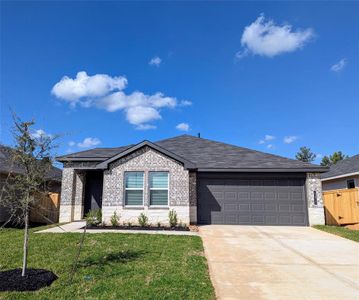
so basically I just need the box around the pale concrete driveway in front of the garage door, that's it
[200,225,359,300]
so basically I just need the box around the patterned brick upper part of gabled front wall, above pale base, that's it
[102,147,189,207]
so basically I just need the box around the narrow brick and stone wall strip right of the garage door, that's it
[306,173,325,225]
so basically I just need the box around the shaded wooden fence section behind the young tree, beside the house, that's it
[30,193,60,224]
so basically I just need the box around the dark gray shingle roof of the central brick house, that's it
[58,135,327,172]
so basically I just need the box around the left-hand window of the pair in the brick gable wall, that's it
[125,172,143,205]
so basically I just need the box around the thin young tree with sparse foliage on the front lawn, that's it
[0,116,56,276]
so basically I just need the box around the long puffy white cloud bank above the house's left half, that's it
[52,72,192,129]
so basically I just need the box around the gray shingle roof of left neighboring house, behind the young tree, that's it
[0,145,62,181]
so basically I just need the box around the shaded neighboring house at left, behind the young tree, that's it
[0,145,62,223]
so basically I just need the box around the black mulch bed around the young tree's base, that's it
[0,269,57,292]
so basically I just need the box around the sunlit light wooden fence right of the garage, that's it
[323,188,359,225]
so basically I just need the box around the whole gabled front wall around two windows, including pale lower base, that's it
[102,147,190,224]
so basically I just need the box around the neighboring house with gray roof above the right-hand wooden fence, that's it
[321,154,359,191]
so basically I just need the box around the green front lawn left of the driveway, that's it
[0,229,215,299]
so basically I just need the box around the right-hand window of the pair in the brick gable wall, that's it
[150,172,168,206]
